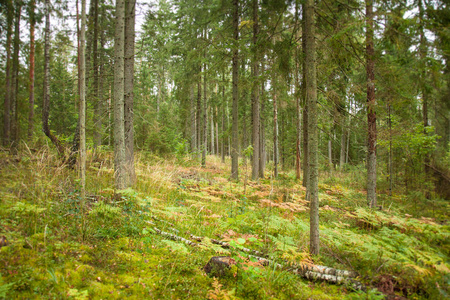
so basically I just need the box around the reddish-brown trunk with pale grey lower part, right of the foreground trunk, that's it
[366,0,377,207]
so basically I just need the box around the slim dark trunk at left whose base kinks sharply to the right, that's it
[42,0,64,156]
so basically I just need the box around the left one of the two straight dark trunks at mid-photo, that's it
[231,0,239,180]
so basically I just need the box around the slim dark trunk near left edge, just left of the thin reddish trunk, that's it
[11,2,22,152]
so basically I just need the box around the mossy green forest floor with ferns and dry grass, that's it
[0,148,450,299]
